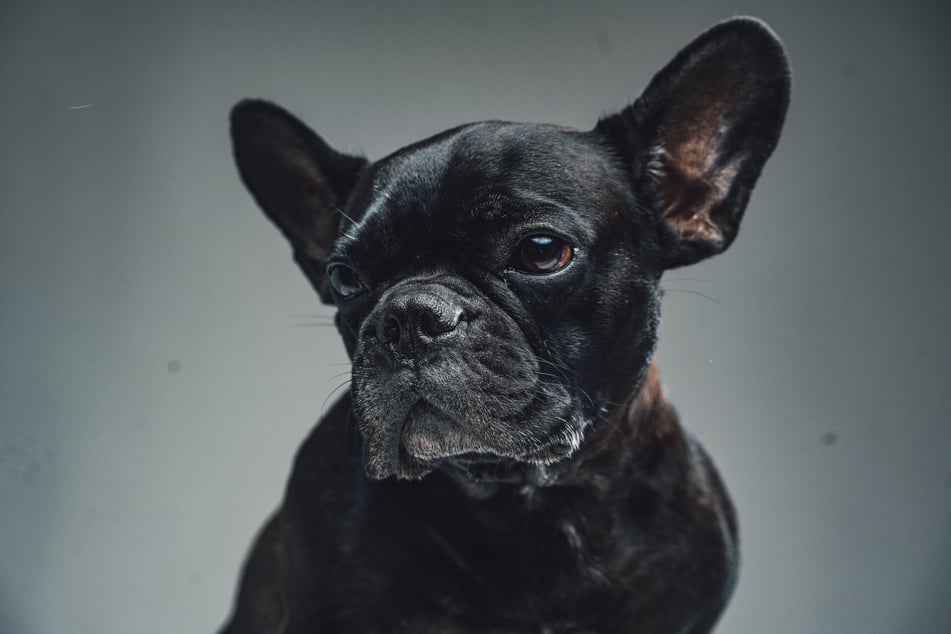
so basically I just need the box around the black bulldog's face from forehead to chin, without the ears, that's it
[327,123,658,477]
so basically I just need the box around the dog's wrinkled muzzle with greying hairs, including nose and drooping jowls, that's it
[353,276,585,481]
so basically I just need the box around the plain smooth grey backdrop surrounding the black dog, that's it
[0,0,951,634]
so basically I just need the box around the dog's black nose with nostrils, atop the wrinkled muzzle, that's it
[376,290,463,353]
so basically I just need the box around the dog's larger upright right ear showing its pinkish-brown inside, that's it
[595,18,790,268]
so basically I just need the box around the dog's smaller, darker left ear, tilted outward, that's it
[231,100,367,304]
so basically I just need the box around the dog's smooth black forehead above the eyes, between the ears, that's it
[340,122,624,251]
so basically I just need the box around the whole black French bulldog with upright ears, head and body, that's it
[223,18,789,634]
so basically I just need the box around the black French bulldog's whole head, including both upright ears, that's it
[232,19,789,480]
